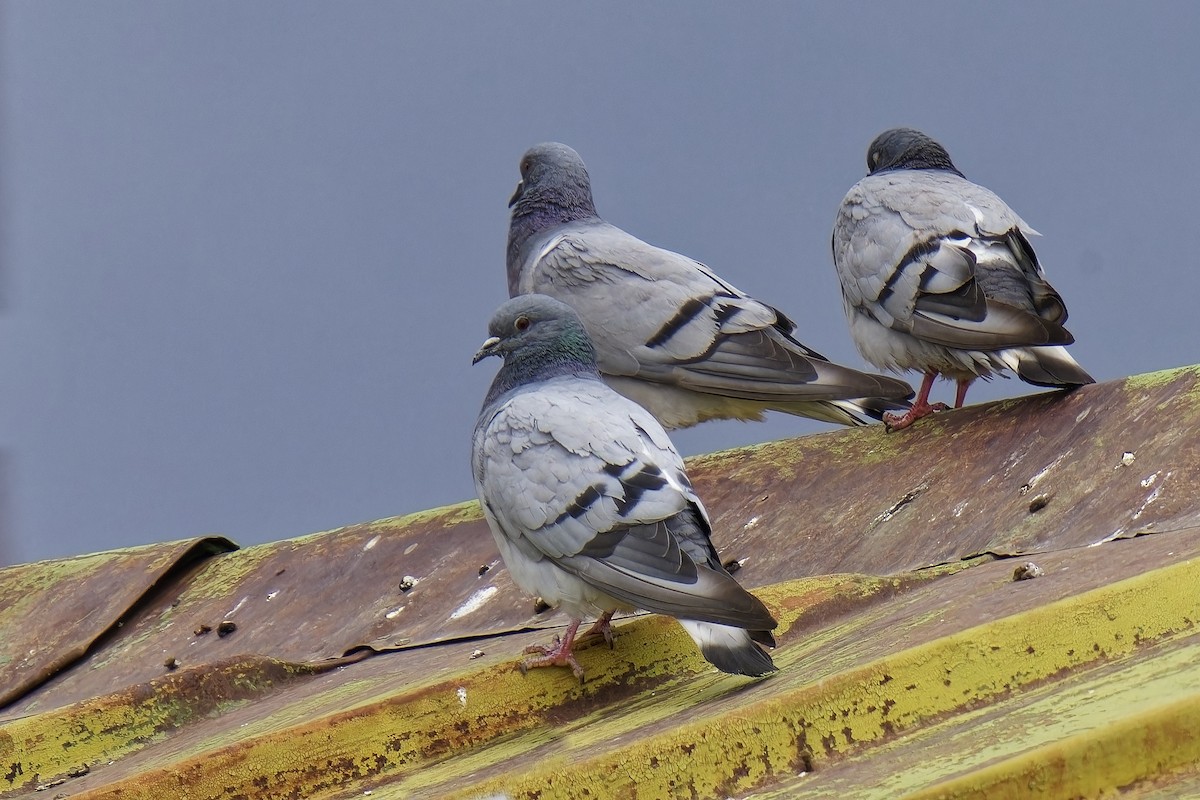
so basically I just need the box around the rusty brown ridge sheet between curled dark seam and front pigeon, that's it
[0,504,542,718]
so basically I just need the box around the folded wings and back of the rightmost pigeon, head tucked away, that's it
[833,170,1072,350]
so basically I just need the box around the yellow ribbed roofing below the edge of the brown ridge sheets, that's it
[0,529,1200,800]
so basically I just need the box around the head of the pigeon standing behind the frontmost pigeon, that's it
[509,142,596,222]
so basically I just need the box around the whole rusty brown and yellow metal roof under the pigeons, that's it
[0,368,1200,800]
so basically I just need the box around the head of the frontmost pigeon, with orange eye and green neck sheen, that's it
[472,294,600,398]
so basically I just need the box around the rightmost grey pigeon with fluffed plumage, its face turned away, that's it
[833,128,1094,429]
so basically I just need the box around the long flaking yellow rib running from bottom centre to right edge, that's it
[450,560,1200,800]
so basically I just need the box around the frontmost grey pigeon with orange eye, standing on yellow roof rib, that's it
[472,295,776,681]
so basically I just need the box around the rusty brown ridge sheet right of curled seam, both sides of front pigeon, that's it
[6,368,1200,715]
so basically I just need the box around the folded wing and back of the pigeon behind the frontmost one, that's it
[518,221,911,403]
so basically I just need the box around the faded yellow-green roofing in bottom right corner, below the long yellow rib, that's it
[751,636,1200,800]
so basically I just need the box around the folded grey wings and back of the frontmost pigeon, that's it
[475,379,775,630]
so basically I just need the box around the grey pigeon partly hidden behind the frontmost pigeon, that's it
[508,143,912,428]
